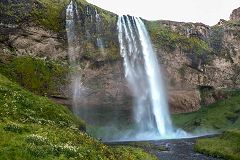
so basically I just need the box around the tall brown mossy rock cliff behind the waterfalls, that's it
[0,0,240,112]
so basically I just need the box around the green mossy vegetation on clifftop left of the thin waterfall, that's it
[0,0,66,31]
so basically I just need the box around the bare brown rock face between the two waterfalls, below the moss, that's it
[79,61,131,107]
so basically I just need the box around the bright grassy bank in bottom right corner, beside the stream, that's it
[195,130,240,160]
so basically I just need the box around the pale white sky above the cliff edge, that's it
[87,0,240,25]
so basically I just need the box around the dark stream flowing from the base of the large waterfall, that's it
[106,138,221,160]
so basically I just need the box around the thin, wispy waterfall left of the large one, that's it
[66,1,83,113]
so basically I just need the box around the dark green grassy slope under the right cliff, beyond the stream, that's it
[173,91,240,132]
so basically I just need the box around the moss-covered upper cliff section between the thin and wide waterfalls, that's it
[71,1,120,62]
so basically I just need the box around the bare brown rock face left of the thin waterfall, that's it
[9,26,67,59]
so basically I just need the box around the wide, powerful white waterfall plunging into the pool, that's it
[118,16,186,140]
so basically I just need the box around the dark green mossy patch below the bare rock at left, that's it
[0,55,68,95]
